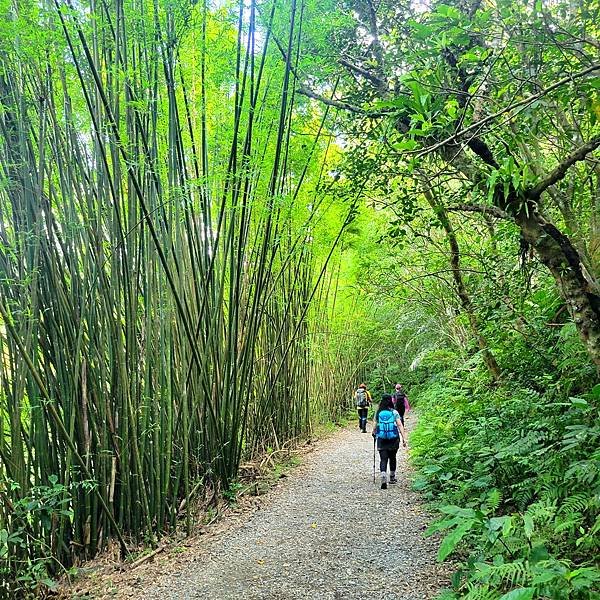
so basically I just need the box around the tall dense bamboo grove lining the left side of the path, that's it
[0,0,356,577]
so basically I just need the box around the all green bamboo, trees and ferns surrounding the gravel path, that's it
[0,0,600,598]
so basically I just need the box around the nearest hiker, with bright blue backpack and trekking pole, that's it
[373,394,407,490]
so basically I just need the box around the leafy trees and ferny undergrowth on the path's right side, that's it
[303,0,600,600]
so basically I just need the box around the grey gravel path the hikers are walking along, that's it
[64,428,448,600]
